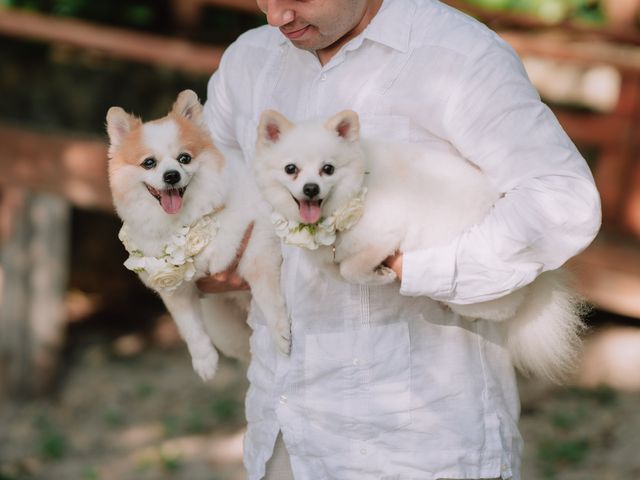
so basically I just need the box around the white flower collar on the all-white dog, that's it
[271,187,367,250]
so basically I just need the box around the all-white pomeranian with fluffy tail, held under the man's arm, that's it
[255,110,583,381]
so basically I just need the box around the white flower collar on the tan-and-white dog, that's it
[118,209,220,292]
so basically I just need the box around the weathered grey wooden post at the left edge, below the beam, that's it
[0,188,70,396]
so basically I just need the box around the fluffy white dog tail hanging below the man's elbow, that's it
[504,270,588,383]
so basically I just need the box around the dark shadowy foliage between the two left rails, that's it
[0,39,208,135]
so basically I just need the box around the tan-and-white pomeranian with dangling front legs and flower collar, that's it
[107,90,290,380]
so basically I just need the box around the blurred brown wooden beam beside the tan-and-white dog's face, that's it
[0,125,113,211]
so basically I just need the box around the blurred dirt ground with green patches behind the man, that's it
[0,317,640,480]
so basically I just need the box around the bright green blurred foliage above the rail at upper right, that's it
[466,0,605,25]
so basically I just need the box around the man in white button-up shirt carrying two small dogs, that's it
[202,0,600,480]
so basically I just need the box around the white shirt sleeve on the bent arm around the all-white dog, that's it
[400,38,600,304]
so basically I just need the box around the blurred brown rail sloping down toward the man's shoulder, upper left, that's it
[0,8,224,74]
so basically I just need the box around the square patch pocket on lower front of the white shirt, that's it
[304,322,411,440]
